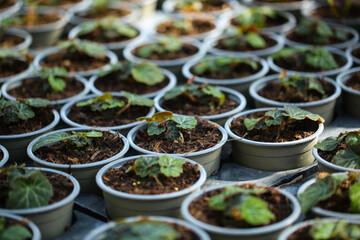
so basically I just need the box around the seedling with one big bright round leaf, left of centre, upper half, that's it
[98,61,165,86]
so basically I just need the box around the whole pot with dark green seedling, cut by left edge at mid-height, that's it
[0,98,60,163]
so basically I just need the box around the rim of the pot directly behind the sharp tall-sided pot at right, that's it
[249,74,341,107]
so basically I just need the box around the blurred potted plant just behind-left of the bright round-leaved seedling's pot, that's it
[34,38,118,76]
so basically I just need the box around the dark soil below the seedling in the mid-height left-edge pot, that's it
[0,108,54,135]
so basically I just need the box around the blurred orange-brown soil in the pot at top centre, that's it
[156,19,215,36]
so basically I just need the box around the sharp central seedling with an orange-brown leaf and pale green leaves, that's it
[137,111,197,143]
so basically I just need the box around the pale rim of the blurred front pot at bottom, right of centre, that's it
[181,183,301,236]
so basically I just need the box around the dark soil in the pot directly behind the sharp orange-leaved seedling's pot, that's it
[161,95,239,116]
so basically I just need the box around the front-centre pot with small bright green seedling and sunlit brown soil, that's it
[96,155,206,219]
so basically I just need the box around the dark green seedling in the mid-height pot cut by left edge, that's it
[0,98,50,124]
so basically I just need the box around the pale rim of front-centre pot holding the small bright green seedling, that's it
[96,154,206,201]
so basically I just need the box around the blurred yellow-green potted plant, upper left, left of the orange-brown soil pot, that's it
[69,17,141,57]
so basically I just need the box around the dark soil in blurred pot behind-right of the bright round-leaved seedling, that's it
[132,43,199,60]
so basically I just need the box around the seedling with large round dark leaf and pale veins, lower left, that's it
[0,165,53,209]
